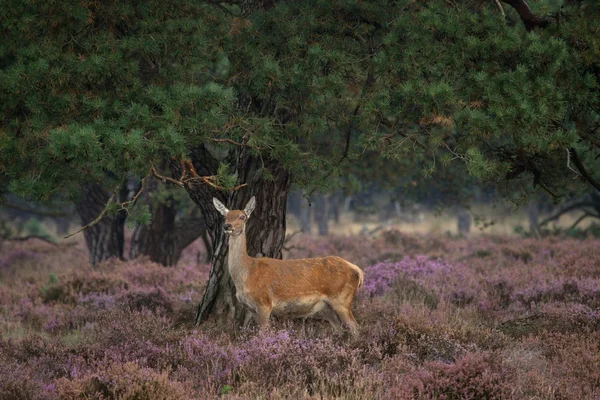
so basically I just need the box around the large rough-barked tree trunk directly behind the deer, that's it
[171,146,290,324]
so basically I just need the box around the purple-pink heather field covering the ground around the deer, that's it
[0,231,600,399]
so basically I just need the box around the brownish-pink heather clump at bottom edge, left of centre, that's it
[56,362,192,400]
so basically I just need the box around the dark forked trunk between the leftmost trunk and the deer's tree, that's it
[129,180,210,267]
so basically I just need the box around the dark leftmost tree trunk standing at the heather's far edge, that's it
[75,184,125,265]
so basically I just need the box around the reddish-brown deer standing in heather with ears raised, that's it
[213,196,364,336]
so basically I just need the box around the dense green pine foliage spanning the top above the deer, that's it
[0,0,600,205]
